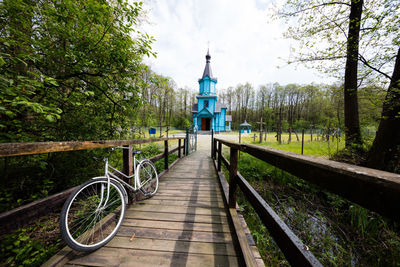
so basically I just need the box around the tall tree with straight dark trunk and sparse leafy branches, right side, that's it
[278,0,399,148]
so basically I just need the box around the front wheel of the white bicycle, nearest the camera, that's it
[60,178,126,252]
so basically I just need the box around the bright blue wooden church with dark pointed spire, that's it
[192,51,232,132]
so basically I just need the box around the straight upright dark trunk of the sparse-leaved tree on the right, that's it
[344,0,364,148]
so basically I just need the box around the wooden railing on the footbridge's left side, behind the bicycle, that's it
[0,137,187,234]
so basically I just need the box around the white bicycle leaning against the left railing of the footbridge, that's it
[60,147,158,252]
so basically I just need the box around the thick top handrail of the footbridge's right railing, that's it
[216,139,400,220]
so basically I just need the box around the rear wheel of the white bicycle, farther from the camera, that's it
[138,160,158,197]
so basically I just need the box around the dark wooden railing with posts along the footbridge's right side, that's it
[211,138,400,266]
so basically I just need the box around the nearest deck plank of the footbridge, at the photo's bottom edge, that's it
[70,247,239,267]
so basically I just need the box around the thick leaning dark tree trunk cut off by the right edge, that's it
[366,47,400,172]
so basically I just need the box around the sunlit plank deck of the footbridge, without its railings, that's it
[49,151,263,266]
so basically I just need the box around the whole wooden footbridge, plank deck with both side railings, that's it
[0,134,400,266]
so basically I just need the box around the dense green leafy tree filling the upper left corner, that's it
[0,0,152,142]
